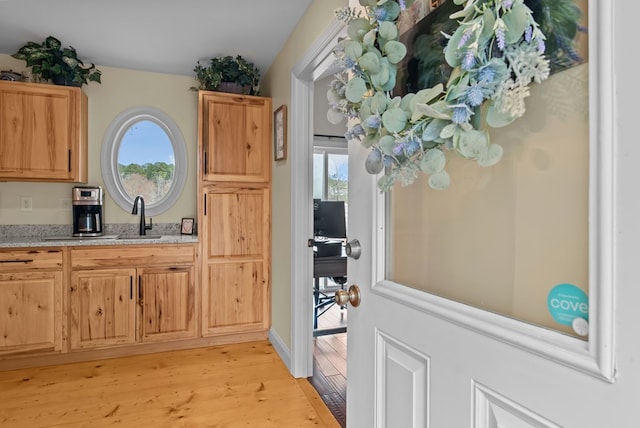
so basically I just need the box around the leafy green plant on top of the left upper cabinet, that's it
[11,36,102,86]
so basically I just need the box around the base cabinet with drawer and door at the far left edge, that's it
[0,249,64,355]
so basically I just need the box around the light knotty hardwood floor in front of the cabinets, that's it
[0,341,339,428]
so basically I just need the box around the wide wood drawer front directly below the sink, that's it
[71,245,196,270]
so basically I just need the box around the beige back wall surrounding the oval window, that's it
[0,54,198,224]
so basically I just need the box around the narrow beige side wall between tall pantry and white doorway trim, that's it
[261,0,347,347]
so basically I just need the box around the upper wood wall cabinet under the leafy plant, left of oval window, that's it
[0,81,88,183]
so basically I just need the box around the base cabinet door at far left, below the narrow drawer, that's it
[0,272,62,355]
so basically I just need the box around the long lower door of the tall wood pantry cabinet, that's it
[202,187,271,335]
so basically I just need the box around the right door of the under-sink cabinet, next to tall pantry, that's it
[138,266,195,342]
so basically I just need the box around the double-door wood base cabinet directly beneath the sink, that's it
[70,245,196,349]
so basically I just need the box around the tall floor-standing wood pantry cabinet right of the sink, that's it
[198,91,272,340]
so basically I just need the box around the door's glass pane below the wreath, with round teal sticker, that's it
[386,0,589,337]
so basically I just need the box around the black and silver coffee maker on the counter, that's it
[71,186,104,236]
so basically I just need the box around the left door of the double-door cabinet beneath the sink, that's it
[70,269,137,349]
